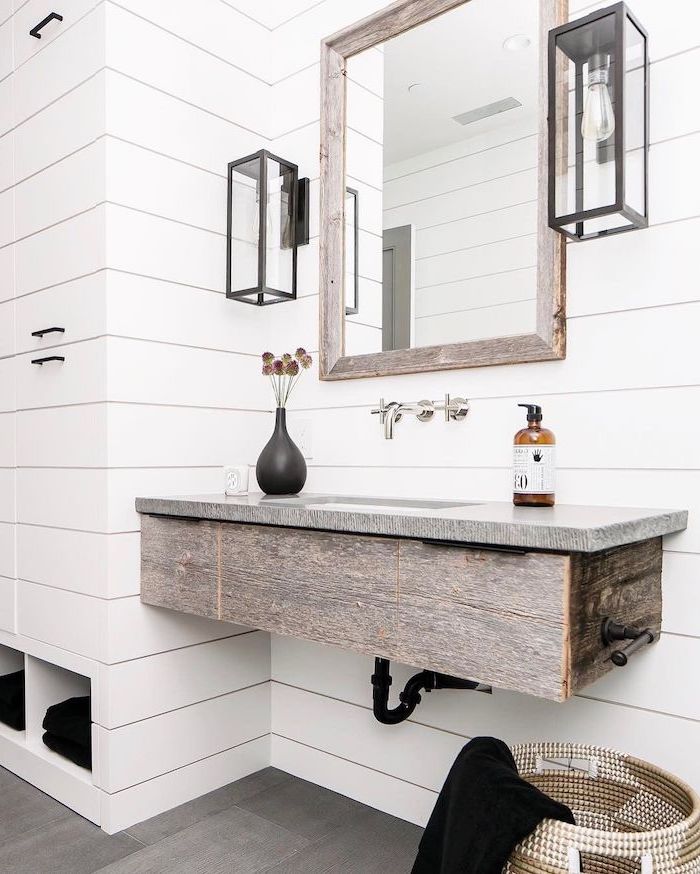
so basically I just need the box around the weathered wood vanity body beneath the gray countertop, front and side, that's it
[142,516,662,701]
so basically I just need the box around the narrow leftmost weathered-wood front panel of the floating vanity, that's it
[141,516,220,619]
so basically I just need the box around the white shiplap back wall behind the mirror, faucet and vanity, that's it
[262,0,700,823]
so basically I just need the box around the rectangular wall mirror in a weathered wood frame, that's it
[319,0,568,380]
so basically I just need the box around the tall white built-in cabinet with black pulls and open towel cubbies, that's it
[0,0,270,832]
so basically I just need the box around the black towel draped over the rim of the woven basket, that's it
[412,737,575,874]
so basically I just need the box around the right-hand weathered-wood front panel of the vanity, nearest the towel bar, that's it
[398,540,569,700]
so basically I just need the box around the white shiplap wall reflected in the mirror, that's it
[384,121,537,346]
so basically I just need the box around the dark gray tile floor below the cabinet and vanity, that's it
[0,768,421,874]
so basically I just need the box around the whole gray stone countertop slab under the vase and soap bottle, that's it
[136,493,688,552]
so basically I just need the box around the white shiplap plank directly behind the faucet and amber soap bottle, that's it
[290,382,700,470]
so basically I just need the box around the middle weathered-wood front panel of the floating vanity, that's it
[220,523,398,657]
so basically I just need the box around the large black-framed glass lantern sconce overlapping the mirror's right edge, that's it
[548,3,649,240]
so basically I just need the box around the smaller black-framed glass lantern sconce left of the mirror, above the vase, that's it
[226,149,309,306]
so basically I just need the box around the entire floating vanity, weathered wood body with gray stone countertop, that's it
[136,495,687,701]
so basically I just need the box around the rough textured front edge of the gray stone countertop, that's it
[136,496,688,552]
